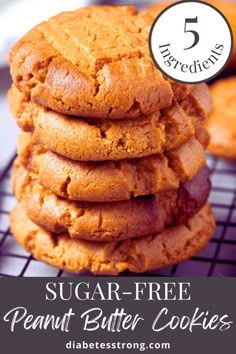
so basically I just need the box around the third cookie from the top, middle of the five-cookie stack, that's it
[18,133,205,202]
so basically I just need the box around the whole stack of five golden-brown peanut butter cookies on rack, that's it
[9,6,214,274]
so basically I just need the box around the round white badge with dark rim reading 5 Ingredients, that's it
[149,1,233,84]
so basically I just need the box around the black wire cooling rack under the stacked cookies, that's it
[0,155,236,277]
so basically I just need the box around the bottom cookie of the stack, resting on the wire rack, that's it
[10,204,215,275]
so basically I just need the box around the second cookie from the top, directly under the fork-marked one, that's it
[8,84,211,161]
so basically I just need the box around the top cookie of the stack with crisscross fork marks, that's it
[9,6,191,119]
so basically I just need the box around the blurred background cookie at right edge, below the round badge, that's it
[207,76,236,159]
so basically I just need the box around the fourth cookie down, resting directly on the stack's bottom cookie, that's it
[12,163,210,241]
